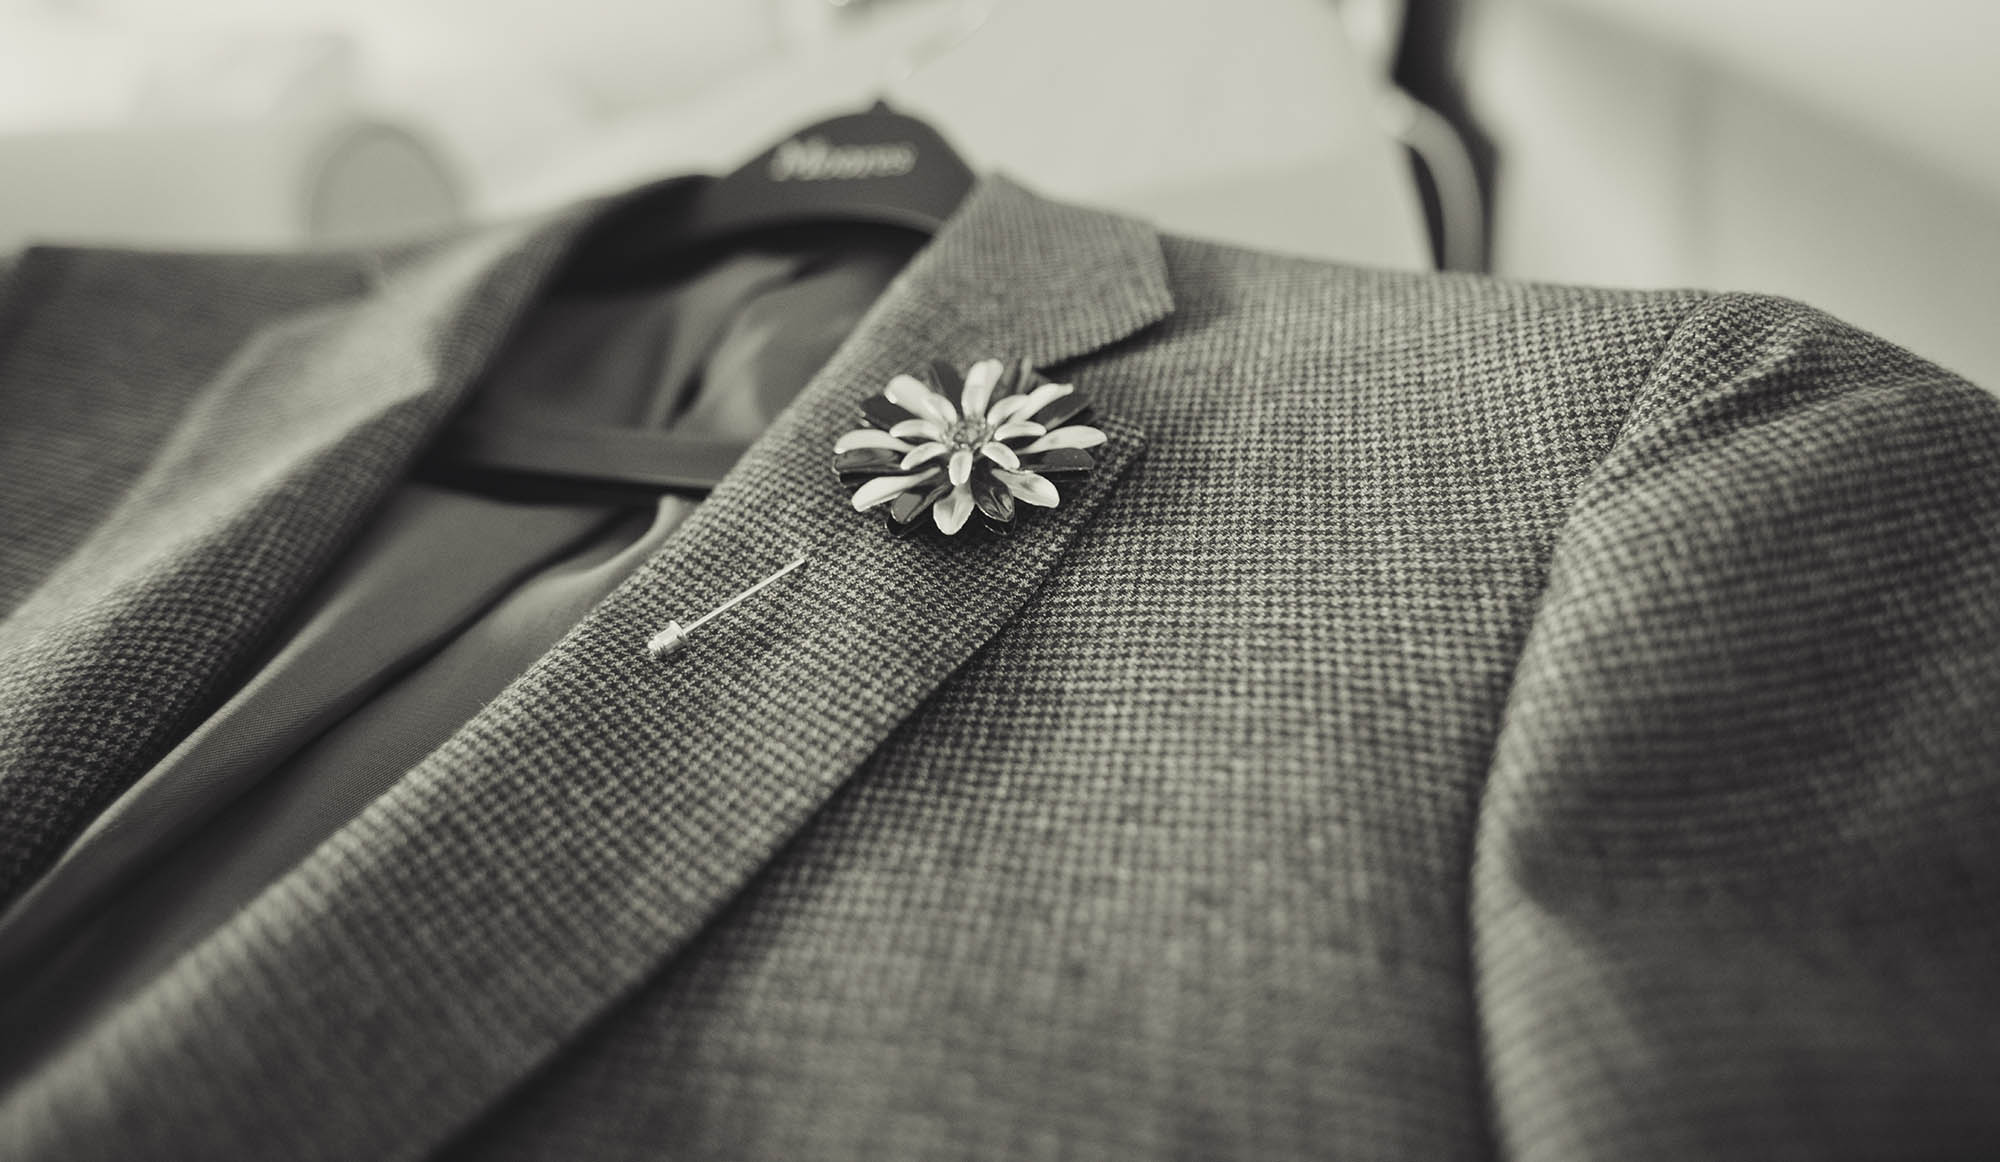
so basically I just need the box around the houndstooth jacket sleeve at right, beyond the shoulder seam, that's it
[1472,296,2000,1160]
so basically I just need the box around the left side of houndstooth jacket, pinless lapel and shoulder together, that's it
[0,226,584,906]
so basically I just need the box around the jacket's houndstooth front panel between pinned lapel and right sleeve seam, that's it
[446,240,1692,1158]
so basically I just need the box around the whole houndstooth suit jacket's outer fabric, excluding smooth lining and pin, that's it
[0,180,2000,1160]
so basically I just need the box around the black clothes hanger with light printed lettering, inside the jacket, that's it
[426,102,976,500]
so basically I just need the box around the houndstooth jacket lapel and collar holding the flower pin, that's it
[0,180,1172,1158]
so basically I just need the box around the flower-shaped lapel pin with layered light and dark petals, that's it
[834,360,1104,536]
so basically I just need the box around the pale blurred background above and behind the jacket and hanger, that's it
[0,0,2000,388]
